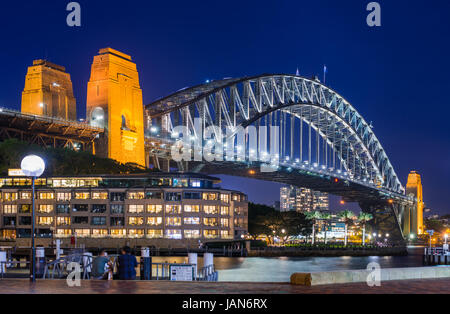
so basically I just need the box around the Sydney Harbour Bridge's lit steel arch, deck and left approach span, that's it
[0,54,418,239]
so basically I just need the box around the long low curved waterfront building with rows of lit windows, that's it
[0,173,248,247]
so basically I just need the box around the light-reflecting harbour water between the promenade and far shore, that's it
[149,247,423,282]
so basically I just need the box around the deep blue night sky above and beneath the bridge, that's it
[0,0,450,213]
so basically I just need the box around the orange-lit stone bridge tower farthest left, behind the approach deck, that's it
[22,60,77,120]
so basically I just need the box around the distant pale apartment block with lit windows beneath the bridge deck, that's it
[280,186,329,212]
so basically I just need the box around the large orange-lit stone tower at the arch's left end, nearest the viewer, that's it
[86,48,145,166]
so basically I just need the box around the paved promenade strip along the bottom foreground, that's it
[0,279,450,294]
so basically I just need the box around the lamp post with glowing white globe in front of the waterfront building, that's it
[20,155,45,282]
